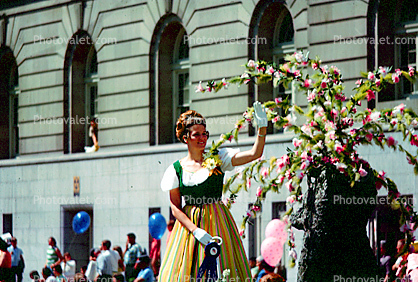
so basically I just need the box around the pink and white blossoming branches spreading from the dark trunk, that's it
[196,52,418,264]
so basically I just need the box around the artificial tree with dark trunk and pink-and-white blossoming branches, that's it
[196,52,418,281]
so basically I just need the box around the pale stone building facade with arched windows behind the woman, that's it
[0,0,418,281]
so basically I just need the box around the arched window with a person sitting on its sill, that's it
[64,30,99,154]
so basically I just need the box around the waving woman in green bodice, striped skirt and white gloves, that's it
[159,102,267,282]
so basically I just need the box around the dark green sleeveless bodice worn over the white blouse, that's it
[173,161,224,206]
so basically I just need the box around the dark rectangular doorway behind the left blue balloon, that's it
[61,205,93,272]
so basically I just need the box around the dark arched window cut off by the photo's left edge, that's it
[0,46,19,159]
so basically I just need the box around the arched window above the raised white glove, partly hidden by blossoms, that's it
[249,0,295,133]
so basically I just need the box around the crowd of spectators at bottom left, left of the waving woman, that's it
[0,233,160,282]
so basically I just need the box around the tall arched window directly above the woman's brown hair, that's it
[150,14,190,145]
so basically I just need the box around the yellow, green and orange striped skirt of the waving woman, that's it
[158,202,251,282]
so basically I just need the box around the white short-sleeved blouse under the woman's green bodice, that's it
[161,148,239,191]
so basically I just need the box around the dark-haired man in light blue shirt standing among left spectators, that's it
[123,233,144,282]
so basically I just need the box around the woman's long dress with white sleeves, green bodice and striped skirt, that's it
[159,149,251,282]
